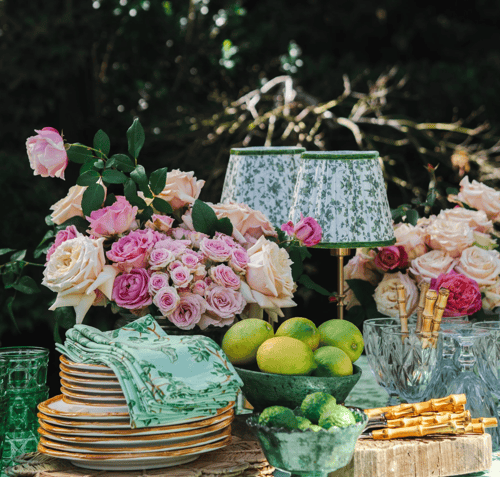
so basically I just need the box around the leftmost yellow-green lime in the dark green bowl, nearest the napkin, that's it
[221,318,274,365]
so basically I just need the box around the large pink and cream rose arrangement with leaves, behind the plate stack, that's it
[2,120,321,330]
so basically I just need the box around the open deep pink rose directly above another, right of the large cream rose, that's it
[106,229,162,272]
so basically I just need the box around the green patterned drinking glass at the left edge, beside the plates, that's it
[0,346,49,467]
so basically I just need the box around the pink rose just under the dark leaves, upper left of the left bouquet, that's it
[87,195,138,237]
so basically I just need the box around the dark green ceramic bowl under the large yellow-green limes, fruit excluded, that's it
[235,365,361,412]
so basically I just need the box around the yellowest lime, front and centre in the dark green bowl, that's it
[257,336,316,375]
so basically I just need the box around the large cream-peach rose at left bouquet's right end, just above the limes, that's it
[240,237,296,319]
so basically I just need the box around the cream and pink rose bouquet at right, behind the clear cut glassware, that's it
[344,177,500,317]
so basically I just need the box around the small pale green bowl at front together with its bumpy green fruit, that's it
[247,392,368,477]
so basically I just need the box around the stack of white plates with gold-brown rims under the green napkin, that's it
[38,357,234,470]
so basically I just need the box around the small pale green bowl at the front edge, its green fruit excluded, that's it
[247,407,368,477]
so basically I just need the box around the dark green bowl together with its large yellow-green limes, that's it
[222,317,363,411]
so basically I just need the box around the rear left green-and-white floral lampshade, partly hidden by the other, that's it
[221,147,305,227]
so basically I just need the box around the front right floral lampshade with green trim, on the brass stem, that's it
[290,151,396,248]
